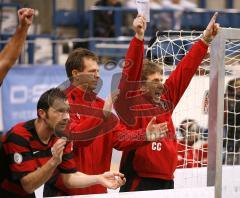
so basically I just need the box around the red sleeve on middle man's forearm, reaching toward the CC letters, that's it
[113,124,148,151]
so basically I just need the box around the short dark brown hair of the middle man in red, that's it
[65,48,98,78]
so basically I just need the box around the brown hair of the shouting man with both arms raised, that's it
[141,59,163,81]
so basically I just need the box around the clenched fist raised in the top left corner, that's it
[18,8,34,28]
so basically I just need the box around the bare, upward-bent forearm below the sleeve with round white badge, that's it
[21,158,57,193]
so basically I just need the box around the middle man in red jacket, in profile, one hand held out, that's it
[44,15,166,197]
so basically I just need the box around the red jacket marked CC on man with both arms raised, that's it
[115,38,208,180]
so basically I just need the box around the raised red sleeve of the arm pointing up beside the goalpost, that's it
[165,40,208,106]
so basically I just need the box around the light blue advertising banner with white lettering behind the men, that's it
[2,65,121,131]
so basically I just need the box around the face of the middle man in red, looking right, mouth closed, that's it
[74,58,100,91]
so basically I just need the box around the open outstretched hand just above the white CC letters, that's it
[146,117,168,141]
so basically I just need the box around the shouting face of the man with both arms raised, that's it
[143,72,163,103]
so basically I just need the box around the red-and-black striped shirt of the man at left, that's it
[0,120,76,197]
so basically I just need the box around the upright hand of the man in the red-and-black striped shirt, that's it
[51,138,67,166]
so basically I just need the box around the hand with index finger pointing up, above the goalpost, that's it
[202,12,220,44]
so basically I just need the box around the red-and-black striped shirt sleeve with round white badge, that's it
[3,132,38,180]
